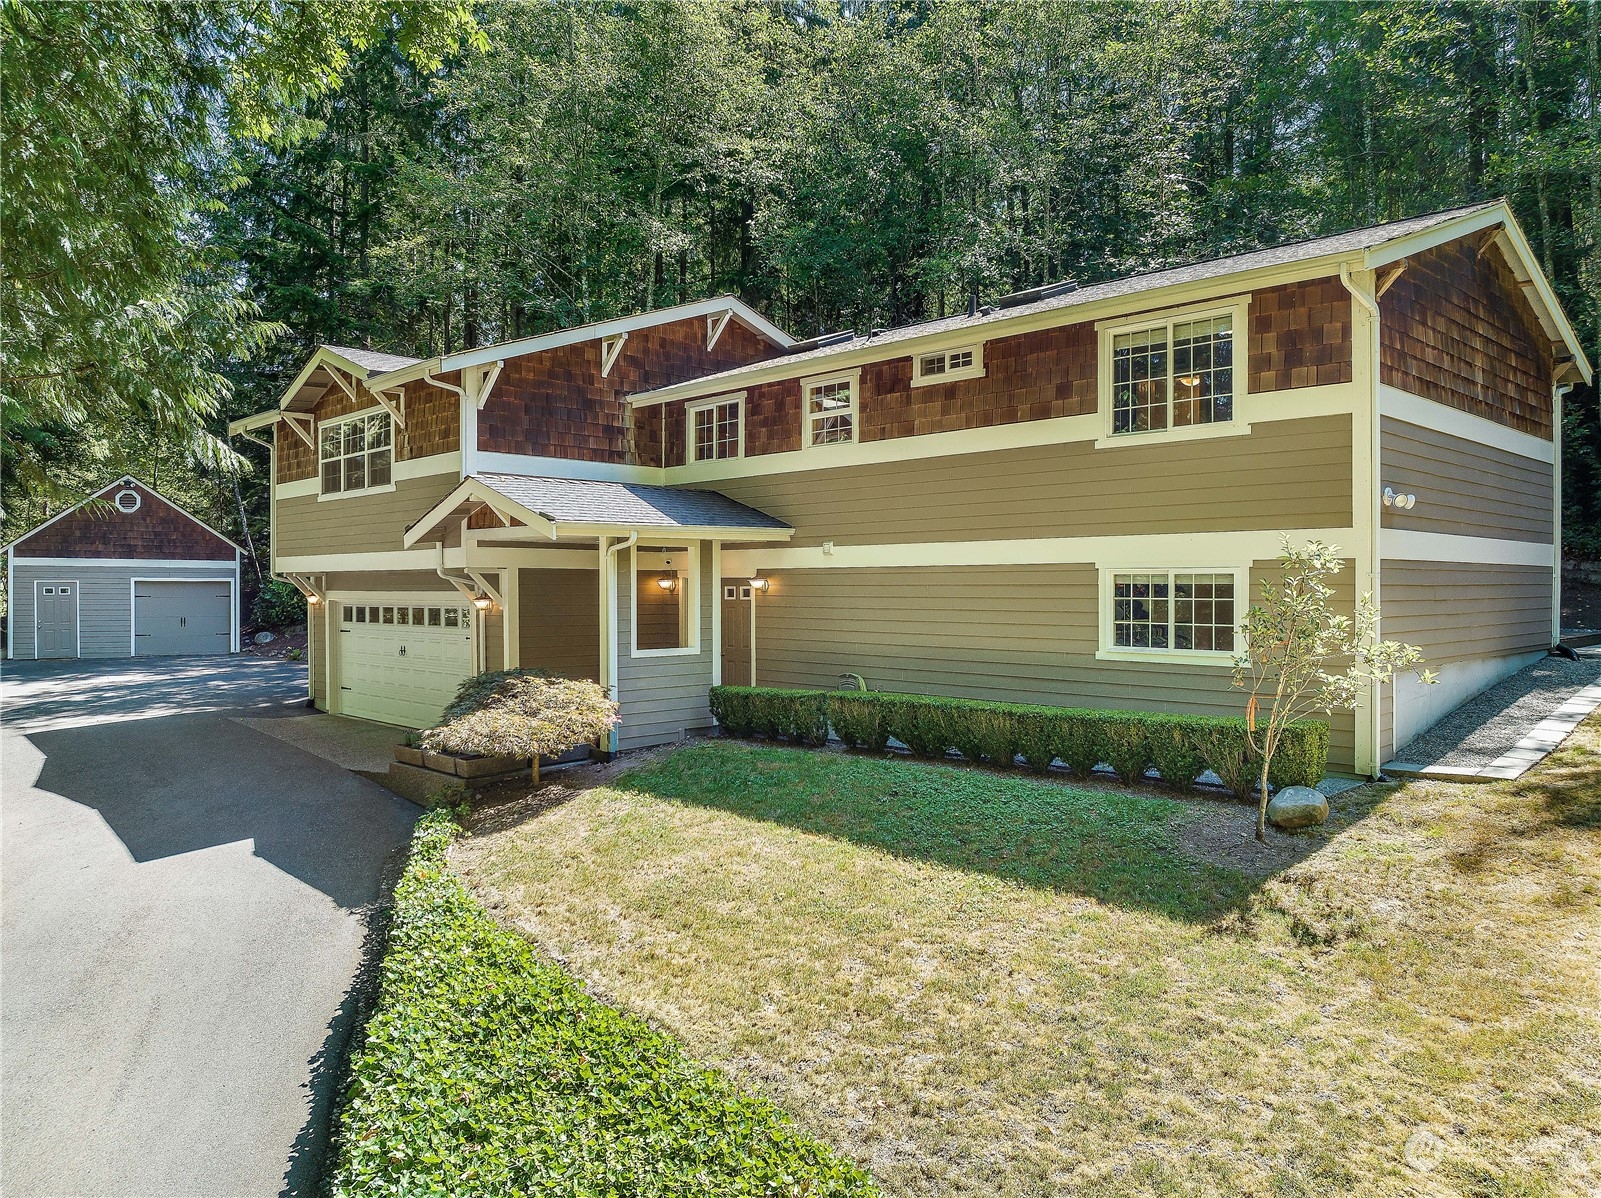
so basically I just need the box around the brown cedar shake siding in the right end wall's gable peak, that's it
[1378,239,1553,440]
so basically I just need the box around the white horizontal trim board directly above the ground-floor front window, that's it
[724,529,1356,577]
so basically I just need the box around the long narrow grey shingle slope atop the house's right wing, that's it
[644,202,1495,394]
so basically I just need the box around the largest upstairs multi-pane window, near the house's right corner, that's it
[1111,312,1234,434]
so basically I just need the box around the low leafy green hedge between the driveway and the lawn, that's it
[330,810,877,1198]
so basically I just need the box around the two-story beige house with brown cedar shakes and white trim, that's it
[234,202,1590,774]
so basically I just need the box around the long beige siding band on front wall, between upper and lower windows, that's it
[716,415,1351,546]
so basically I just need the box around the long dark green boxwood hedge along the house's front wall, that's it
[711,687,1329,796]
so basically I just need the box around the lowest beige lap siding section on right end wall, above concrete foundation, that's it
[1380,560,1551,666]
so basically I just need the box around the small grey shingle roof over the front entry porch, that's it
[472,474,789,532]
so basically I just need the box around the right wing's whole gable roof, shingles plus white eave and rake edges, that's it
[629,200,1590,407]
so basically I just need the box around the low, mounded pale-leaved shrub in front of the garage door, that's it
[419,669,616,758]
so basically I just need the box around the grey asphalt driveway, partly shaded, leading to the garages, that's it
[0,657,418,1198]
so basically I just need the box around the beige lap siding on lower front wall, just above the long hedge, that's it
[756,562,1354,770]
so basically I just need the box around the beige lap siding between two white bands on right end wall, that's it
[1378,416,1553,543]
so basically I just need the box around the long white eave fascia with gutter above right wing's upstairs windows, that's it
[628,248,1362,408]
